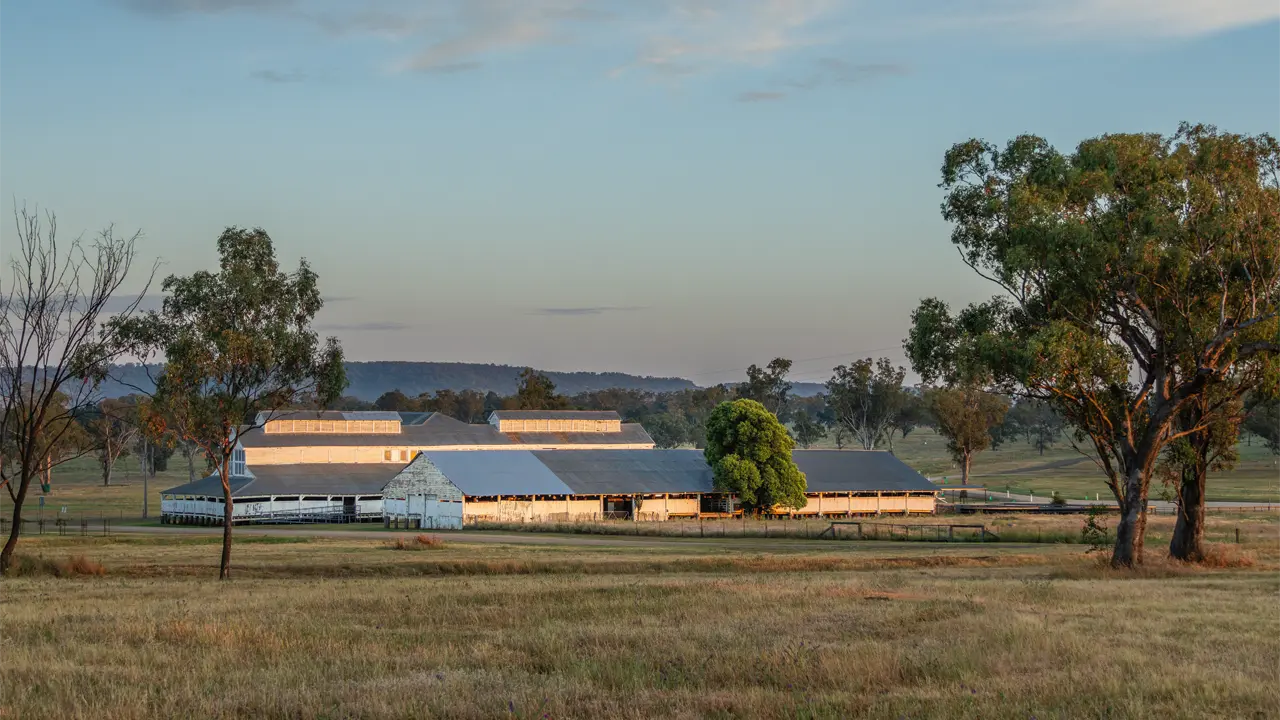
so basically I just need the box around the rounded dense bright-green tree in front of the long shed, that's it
[704,400,808,512]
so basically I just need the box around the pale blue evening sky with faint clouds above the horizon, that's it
[0,0,1280,384]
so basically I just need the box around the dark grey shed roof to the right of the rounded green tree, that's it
[791,450,937,492]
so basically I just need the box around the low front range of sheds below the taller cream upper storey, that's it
[161,448,937,528]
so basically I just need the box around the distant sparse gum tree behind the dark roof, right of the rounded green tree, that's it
[827,357,908,450]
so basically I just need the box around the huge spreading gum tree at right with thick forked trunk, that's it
[909,126,1280,566]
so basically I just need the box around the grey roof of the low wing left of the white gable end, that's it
[163,462,404,497]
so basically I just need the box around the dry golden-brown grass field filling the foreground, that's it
[0,519,1280,720]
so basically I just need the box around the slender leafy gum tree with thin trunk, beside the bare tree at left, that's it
[115,228,347,579]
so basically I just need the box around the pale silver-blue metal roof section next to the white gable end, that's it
[424,450,573,497]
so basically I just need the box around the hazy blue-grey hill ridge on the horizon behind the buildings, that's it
[99,361,696,401]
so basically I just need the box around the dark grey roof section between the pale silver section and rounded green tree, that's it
[534,450,714,495]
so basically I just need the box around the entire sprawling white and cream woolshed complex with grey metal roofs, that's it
[161,411,937,520]
